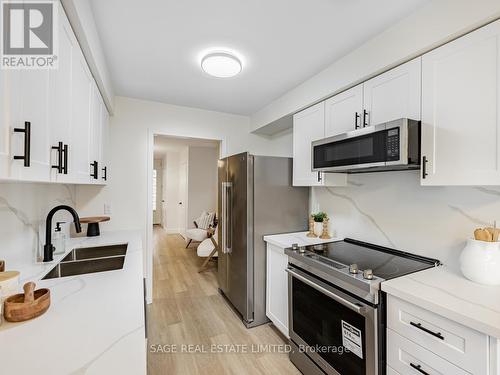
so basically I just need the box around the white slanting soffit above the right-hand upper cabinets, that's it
[251,0,500,132]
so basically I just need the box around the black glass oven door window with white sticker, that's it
[292,278,366,375]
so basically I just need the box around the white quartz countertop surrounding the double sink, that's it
[0,231,146,375]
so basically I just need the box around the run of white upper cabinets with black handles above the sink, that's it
[0,2,108,184]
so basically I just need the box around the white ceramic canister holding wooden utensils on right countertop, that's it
[460,239,500,285]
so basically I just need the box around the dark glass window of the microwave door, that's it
[314,130,387,168]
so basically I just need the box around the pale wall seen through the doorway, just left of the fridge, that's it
[187,147,219,228]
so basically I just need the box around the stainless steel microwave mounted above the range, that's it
[312,118,421,173]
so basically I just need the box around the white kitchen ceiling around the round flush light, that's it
[90,0,429,115]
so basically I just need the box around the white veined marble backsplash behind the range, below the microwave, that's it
[310,171,500,269]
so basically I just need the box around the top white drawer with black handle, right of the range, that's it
[387,296,489,374]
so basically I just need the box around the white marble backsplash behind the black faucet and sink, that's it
[0,182,76,269]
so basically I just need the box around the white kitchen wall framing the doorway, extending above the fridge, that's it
[77,97,292,301]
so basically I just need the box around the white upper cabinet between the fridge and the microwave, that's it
[293,102,346,186]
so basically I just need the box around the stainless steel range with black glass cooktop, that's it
[285,239,440,375]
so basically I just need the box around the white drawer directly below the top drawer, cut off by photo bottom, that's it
[387,328,470,375]
